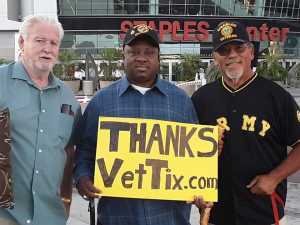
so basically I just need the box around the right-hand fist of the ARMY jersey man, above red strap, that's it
[247,174,278,195]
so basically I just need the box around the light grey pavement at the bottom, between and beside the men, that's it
[68,182,300,225]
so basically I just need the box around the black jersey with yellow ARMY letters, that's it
[192,75,300,225]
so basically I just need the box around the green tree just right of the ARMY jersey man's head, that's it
[256,42,288,82]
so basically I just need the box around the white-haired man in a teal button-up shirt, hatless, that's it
[0,16,81,225]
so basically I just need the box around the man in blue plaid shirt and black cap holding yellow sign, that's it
[75,25,197,225]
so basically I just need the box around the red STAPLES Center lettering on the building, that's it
[120,20,289,42]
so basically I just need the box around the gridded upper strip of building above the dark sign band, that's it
[58,0,300,18]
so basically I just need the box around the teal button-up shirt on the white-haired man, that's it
[0,62,81,225]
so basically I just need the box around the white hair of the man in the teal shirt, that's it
[19,15,64,41]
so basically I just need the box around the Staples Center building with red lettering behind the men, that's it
[57,0,300,80]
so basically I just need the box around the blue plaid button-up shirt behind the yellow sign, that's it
[75,78,197,225]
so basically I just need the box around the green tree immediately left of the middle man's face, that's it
[99,48,122,80]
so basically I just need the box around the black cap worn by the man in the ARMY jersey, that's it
[213,21,250,51]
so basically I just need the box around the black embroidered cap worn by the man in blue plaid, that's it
[123,24,159,48]
